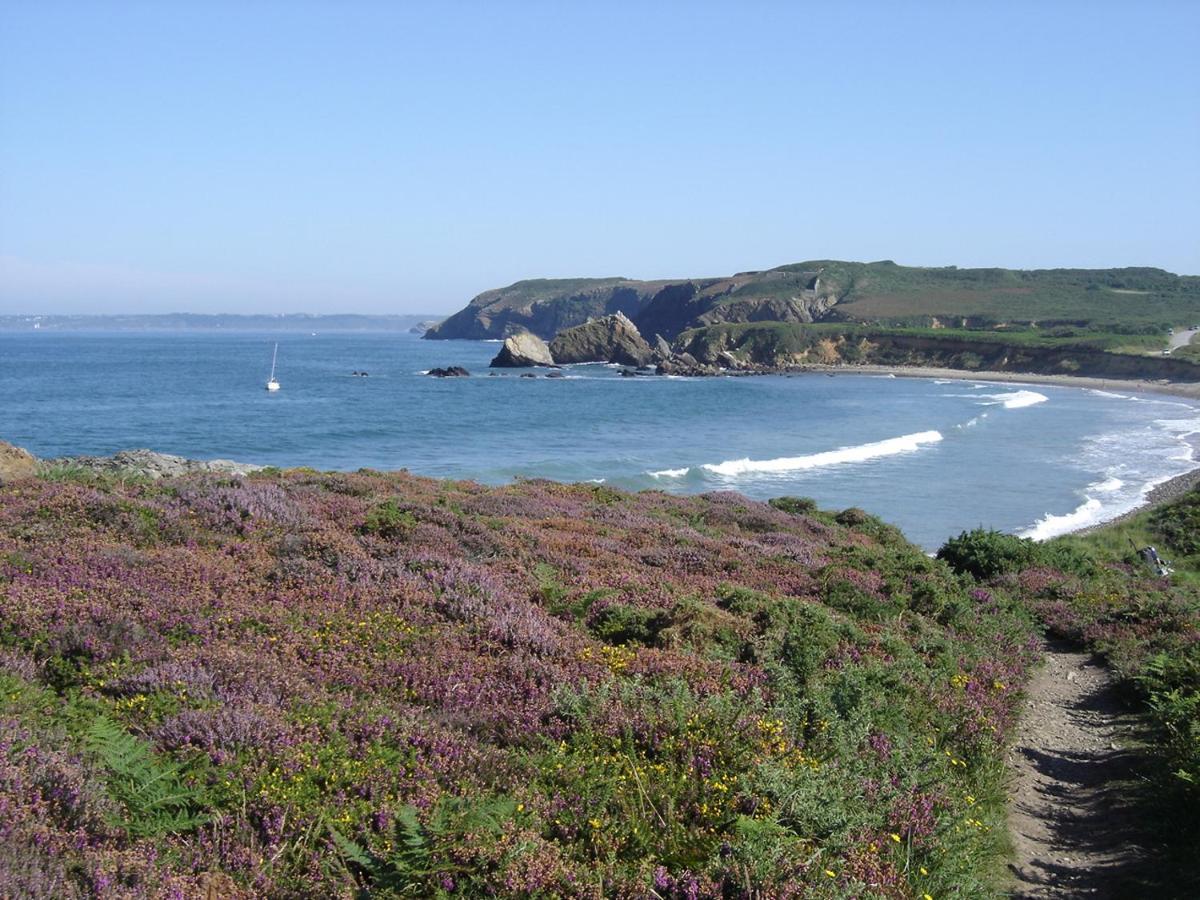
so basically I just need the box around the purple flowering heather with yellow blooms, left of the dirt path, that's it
[0,470,1036,900]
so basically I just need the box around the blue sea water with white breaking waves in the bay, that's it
[0,331,1200,548]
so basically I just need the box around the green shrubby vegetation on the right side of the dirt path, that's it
[938,488,1200,896]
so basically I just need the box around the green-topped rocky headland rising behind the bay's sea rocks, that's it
[426,259,1200,340]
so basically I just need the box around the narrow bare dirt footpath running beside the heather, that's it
[1008,646,1148,899]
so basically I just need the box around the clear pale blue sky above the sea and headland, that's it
[0,0,1200,313]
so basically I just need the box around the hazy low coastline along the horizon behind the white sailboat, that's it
[0,313,440,331]
